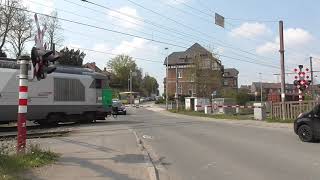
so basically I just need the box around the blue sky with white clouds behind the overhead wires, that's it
[20,0,320,94]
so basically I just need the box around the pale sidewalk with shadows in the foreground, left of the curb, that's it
[25,125,149,180]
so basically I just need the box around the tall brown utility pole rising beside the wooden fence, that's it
[279,21,286,119]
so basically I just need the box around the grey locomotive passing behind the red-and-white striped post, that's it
[0,60,112,124]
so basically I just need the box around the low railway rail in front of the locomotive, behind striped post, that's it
[0,130,71,139]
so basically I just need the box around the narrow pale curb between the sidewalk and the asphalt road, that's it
[130,129,159,180]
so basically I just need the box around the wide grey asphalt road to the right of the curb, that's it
[124,105,320,180]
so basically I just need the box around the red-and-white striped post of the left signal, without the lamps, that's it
[17,56,30,153]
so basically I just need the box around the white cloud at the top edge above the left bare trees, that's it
[23,0,55,14]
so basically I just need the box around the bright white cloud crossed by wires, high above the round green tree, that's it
[108,6,142,28]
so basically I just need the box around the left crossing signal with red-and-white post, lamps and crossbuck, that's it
[17,14,59,153]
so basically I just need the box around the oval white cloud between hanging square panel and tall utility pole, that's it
[230,22,271,38]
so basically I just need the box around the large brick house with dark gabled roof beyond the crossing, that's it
[164,43,223,97]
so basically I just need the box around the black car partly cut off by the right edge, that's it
[294,104,320,142]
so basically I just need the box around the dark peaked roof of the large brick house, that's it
[163,43,212,65]
